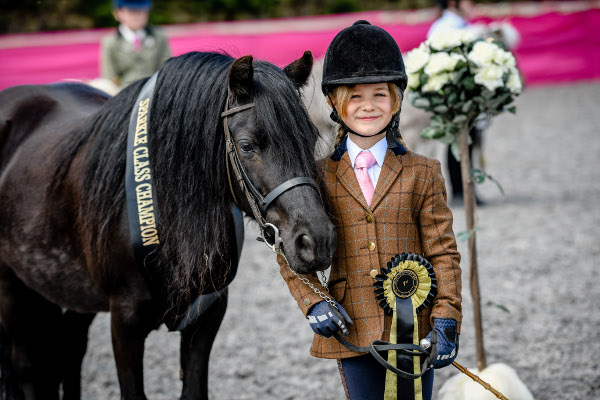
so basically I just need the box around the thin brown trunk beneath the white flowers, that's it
[458,124,487,371]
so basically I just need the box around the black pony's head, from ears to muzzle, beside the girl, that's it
[227,52,335,273]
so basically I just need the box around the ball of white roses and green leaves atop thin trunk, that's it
[405,29,522,151]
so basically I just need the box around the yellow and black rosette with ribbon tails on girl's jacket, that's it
[373,253,437,400]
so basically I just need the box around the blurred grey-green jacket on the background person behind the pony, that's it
[100,26,171,88]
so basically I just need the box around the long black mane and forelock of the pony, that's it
[52,53,318,304]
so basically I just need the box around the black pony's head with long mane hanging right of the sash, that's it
[145,53,336,295]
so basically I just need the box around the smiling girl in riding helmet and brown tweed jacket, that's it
[278,21,462,400]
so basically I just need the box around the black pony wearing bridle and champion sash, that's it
[0,52,335,399]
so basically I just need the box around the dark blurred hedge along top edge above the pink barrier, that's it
[0,0,510,33]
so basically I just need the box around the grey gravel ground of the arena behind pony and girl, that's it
[82,83,600,400]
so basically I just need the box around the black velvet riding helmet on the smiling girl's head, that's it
[321,20,407,96]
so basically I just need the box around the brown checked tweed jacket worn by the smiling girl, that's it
[278,141,462,359]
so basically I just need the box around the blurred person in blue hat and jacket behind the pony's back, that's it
[100,0,171,89]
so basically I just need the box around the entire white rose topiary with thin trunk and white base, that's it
[406,30,533,400]
